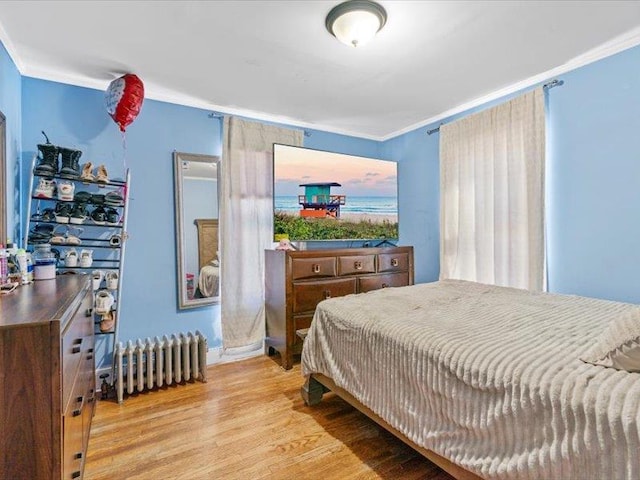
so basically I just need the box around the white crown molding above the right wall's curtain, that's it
[380,27,640,142]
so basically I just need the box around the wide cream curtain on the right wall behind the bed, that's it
[440,88,546,291]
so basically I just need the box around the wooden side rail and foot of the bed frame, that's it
[300,373,482,480]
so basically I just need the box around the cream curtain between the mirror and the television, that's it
[220,117,303,348]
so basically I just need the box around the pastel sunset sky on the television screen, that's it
[274,145,398,197]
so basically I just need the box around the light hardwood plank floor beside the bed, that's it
[84,356,453,480]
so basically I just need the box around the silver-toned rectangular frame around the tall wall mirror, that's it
[173,151,220,310]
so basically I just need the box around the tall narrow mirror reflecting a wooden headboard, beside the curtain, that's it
[173,152,220,309]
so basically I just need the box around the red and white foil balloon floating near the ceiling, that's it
[105,73,144,132]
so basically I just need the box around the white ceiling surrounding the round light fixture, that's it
[0,0,640,139]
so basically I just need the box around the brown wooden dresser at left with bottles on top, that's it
[0,275,95,480]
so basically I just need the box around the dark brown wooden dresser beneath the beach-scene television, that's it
[265,247,413,370]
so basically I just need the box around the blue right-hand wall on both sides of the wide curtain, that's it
[381,42,640,303]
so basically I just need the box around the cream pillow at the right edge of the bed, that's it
[580,308,640,372]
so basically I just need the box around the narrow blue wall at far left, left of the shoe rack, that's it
[0,43,22,243]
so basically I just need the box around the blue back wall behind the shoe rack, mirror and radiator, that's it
[21,77,379,366]
